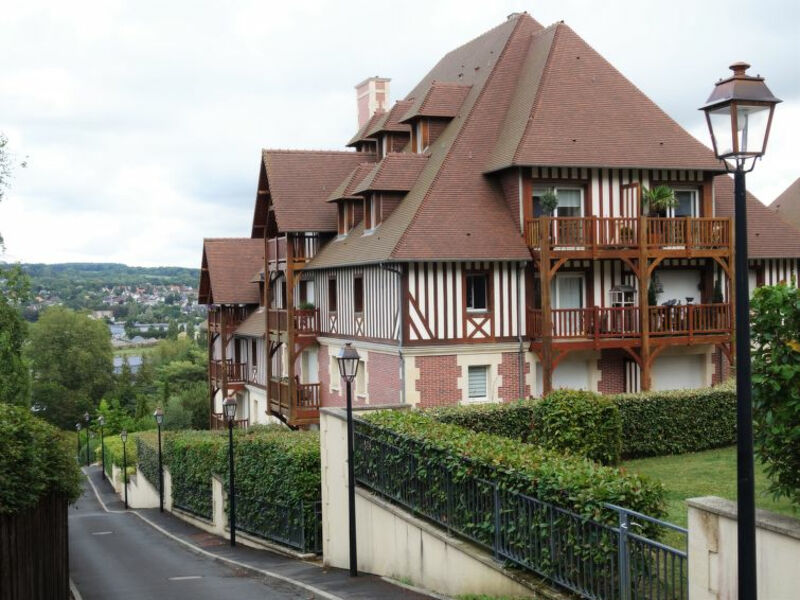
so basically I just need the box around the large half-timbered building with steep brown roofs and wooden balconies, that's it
[200,13,800,426]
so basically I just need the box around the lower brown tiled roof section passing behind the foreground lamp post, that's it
[714,175,800,258]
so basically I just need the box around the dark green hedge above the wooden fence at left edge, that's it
[0,404,80,514]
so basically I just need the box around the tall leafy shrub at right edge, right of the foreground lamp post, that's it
[751,282,800,505]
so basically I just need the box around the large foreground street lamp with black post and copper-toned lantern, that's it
[700,62,780,600]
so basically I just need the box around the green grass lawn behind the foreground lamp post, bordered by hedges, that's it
[622,446,800,545]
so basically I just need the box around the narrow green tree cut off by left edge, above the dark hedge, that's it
[0,264,30,406]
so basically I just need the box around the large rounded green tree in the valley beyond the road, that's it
[26,306,113,429]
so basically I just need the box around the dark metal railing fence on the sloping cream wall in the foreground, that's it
[354,421,688,600]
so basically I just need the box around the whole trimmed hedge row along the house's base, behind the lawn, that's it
[426,382,736,465]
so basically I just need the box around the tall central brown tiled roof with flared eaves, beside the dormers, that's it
[307,14,541,268]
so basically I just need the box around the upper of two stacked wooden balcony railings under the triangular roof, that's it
[525,217,731,258]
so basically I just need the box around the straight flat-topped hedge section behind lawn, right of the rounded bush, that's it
[613,382,736,458]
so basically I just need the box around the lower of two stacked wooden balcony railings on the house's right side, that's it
[528,304,732,340]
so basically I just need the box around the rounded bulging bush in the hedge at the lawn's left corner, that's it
[529,390,622,465]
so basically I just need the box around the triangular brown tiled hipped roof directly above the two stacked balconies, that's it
[486,23,724,171]
